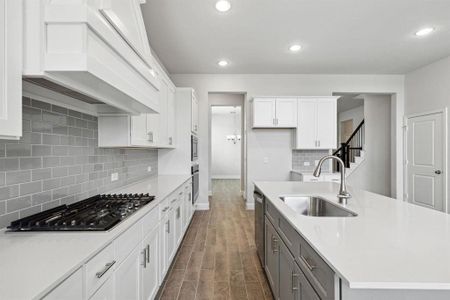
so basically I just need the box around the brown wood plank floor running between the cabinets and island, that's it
[160,180,273,300]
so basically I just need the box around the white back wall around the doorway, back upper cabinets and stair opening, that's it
[172,74,404,208]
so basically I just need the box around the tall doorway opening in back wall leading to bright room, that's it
[209,93,245,196]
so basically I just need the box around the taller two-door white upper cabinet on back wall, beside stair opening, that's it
[296,97,337,149]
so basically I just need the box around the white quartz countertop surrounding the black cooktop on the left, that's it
[0,175,190,300]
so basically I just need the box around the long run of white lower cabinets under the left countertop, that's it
[42,180,193,300]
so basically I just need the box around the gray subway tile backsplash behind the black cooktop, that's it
[0,97,158,228]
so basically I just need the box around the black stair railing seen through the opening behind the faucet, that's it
[333,120,365,171]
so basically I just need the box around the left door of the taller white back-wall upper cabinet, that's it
[296,99,317,149]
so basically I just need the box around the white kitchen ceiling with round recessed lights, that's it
[142,0,450,74]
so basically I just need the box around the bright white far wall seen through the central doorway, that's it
[211,107,241,179]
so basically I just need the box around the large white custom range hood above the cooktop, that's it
[23,0,160,114]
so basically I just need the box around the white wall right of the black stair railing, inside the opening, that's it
[348,95,391,196]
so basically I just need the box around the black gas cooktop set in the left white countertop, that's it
[8,194,155,231]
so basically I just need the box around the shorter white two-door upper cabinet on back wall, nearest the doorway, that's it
[253,98,297,128]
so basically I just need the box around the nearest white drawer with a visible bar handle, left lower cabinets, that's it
[85,244,116,298]
